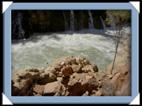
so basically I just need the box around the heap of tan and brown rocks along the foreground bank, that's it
[12,56,130,96]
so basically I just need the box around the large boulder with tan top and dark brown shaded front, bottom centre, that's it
[68,73,98,96]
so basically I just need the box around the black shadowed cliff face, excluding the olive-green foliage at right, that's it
[12,10,105,39]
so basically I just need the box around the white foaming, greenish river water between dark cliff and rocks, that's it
[12,33,115,70]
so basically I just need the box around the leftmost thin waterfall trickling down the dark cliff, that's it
[17,13,25,39]
